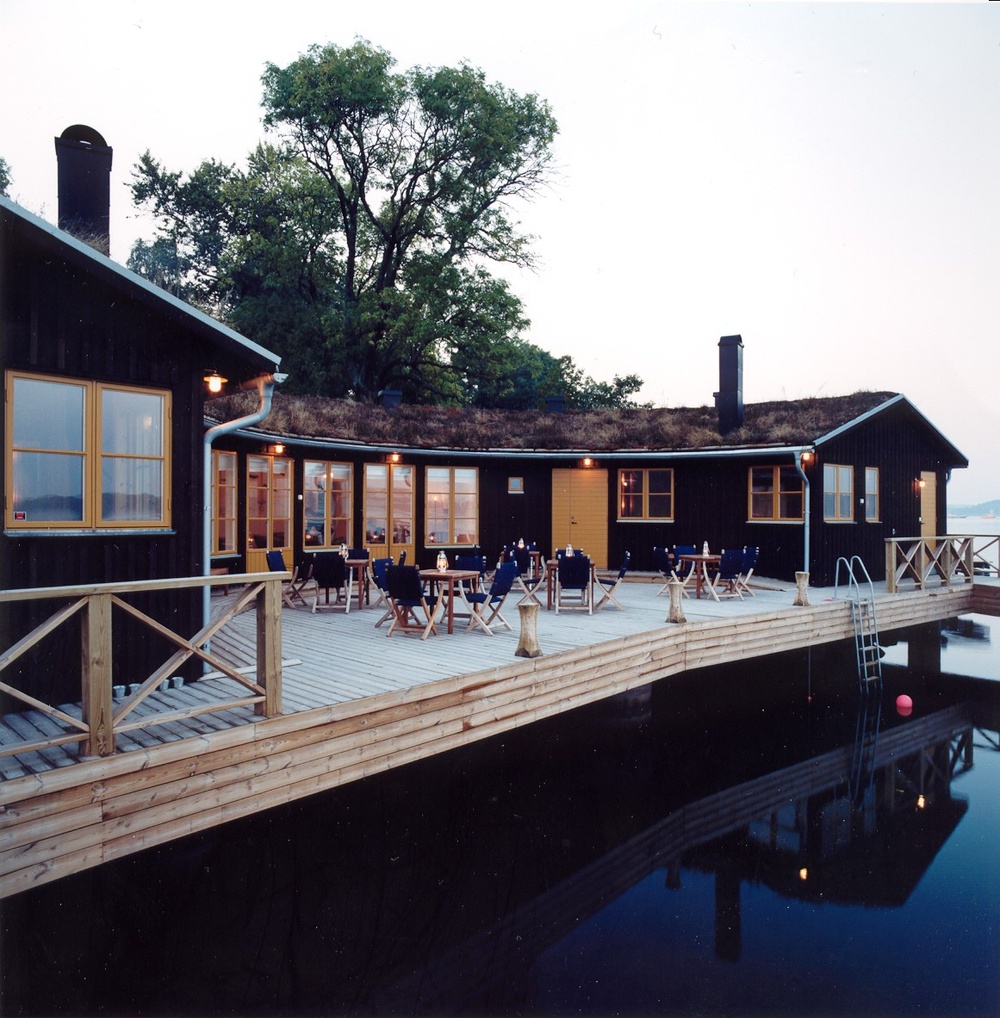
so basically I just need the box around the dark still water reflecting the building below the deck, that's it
[0,617,1000,1015]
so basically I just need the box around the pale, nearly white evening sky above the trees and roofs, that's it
[0,0,1000,504]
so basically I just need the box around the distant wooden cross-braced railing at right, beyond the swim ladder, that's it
[885,533,1000,593]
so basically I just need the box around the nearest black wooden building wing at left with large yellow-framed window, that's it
[0,181,279,699]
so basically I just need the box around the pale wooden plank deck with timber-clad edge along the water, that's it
[0,579,1000,894]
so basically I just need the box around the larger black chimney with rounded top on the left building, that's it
[56,124,111,255]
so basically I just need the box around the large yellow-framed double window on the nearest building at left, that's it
[4,372,171,529]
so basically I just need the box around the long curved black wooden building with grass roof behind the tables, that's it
[209,337,967,585]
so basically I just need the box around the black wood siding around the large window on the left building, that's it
[0,215,246,701]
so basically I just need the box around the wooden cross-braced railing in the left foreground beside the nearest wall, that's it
[0,572,290,756]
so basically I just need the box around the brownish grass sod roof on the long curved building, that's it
[205,391,896,452]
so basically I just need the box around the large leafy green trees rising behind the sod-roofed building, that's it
[129,40,642,406]
